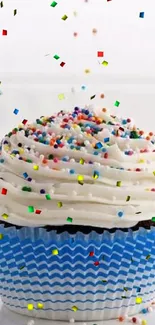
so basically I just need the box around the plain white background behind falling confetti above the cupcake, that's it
[0,0,155,136]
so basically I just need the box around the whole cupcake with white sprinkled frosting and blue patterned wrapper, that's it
[0,107,155,321]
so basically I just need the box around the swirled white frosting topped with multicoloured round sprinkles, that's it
[0,107,155,228]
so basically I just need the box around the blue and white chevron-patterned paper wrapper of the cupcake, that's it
[0,225,155,321]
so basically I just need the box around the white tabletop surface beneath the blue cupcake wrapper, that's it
[0,300,155,325]
